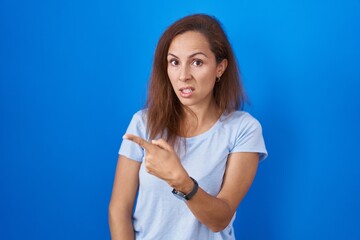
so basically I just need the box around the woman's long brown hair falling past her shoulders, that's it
[146,14,245,144]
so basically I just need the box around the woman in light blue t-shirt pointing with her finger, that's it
[109,14,267,240]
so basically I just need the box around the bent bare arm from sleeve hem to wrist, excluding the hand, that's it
[179,153,259,232]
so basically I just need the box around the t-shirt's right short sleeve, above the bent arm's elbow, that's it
[230,114,268,161]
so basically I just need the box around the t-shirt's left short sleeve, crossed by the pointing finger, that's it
[119,110,148,162]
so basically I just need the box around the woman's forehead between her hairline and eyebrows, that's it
[169,31,211,54]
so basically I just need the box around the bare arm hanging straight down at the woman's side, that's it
[109,156,140,240]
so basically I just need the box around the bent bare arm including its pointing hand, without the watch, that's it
[125,135,259,232]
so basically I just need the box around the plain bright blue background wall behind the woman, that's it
[0,0,360,240]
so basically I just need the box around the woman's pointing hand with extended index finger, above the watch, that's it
[124,134,189,188]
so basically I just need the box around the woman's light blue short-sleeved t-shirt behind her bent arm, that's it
[119,110,267,240]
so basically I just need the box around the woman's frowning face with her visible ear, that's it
[167,31,227,108]
